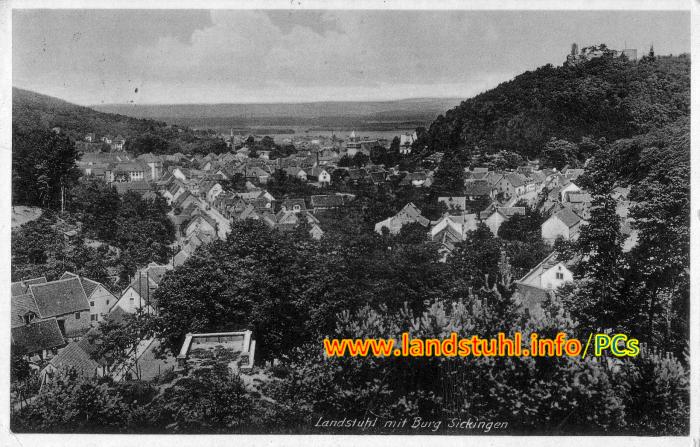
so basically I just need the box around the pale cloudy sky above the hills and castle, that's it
[12,10,690,105]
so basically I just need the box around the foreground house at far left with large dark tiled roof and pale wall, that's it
[29,278,90,339]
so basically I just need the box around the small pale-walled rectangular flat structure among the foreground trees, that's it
[177,330,255,371]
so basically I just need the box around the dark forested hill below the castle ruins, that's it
[414,54,690,157]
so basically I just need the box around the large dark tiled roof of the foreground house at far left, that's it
[29,278,90,318]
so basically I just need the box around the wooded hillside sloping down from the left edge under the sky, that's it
[12,87,183,140]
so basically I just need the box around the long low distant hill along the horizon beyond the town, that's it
[93,98,460,128]
